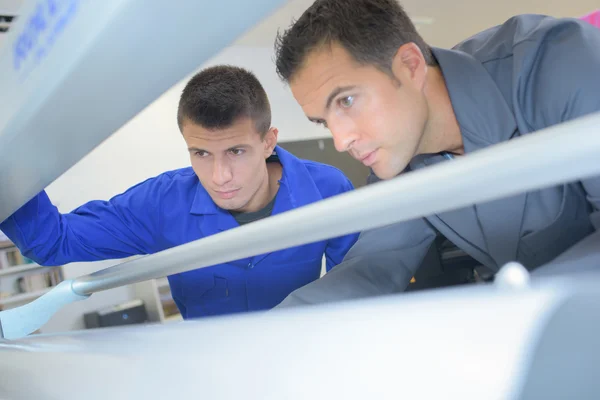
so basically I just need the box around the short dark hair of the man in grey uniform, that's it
[275,0,437,83]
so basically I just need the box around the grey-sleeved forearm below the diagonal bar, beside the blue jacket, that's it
[277,219,435,308]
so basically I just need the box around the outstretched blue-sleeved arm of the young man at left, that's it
[0,179,166,265]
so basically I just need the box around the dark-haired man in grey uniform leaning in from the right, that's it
[276,0,600,306]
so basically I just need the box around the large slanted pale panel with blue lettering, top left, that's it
[0,0,285,221]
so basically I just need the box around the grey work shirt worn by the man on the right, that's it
[280,15,600,307]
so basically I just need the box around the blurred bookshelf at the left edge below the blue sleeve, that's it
[0,239,64,310]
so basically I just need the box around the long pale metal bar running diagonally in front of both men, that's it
[73,113,600,295]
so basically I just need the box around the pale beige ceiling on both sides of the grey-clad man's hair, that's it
[236,0,600,47]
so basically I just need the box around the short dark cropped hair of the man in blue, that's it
[177,65,271,135]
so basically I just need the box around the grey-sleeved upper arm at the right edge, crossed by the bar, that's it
[520,20,600,229]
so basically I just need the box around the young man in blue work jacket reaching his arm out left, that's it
[0,66,357,318]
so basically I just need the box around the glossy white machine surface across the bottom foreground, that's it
[0,275,600,400]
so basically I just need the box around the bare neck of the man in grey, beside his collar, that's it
[418,67,464,154]
